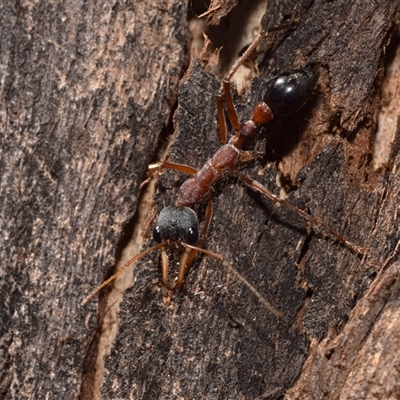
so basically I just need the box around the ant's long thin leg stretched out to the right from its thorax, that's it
[235,171,368,254]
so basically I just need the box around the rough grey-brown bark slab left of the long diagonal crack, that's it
[0,1,187,399]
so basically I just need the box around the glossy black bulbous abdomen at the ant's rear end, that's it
[263,68,318,118]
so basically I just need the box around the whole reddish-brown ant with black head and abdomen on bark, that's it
[82,24,368,317]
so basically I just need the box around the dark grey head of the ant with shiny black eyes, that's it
[153,206,199,244]
